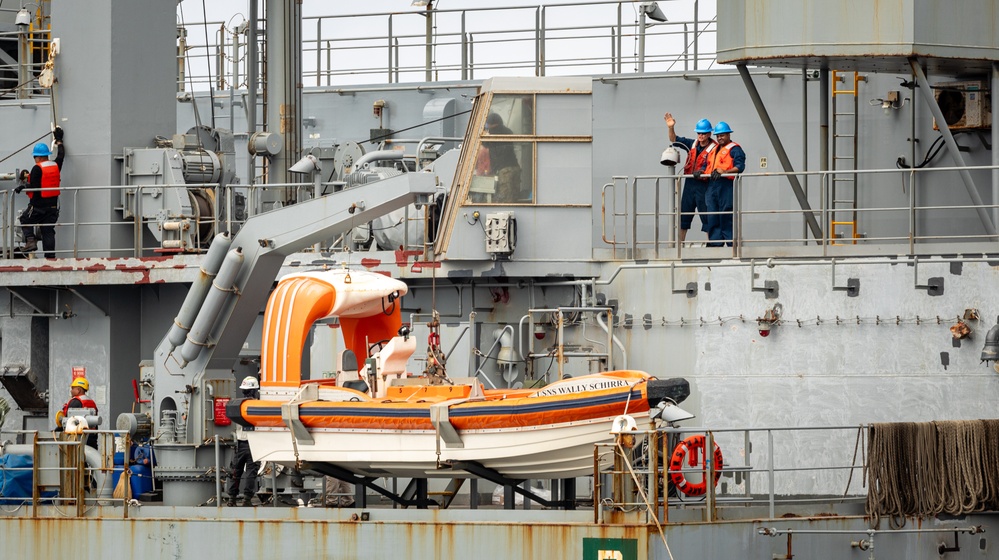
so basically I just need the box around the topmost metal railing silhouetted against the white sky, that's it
[178,0,716,90]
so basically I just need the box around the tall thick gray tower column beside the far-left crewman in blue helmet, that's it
[52,0,177,252]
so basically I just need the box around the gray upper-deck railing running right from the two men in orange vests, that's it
[600,162,999,259]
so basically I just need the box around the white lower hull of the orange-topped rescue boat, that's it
[247,414,651,479]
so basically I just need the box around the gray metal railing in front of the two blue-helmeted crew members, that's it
[600,165,999,259]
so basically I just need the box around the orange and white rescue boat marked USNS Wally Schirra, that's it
[228,271,689,479]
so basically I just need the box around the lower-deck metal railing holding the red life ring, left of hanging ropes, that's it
[593,426,867,523]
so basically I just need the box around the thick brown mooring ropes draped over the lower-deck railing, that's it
[866,420,999,529]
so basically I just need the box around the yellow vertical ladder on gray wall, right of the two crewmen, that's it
[829,70,867,245]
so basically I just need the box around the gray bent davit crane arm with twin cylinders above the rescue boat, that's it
[143,172,438,444]
